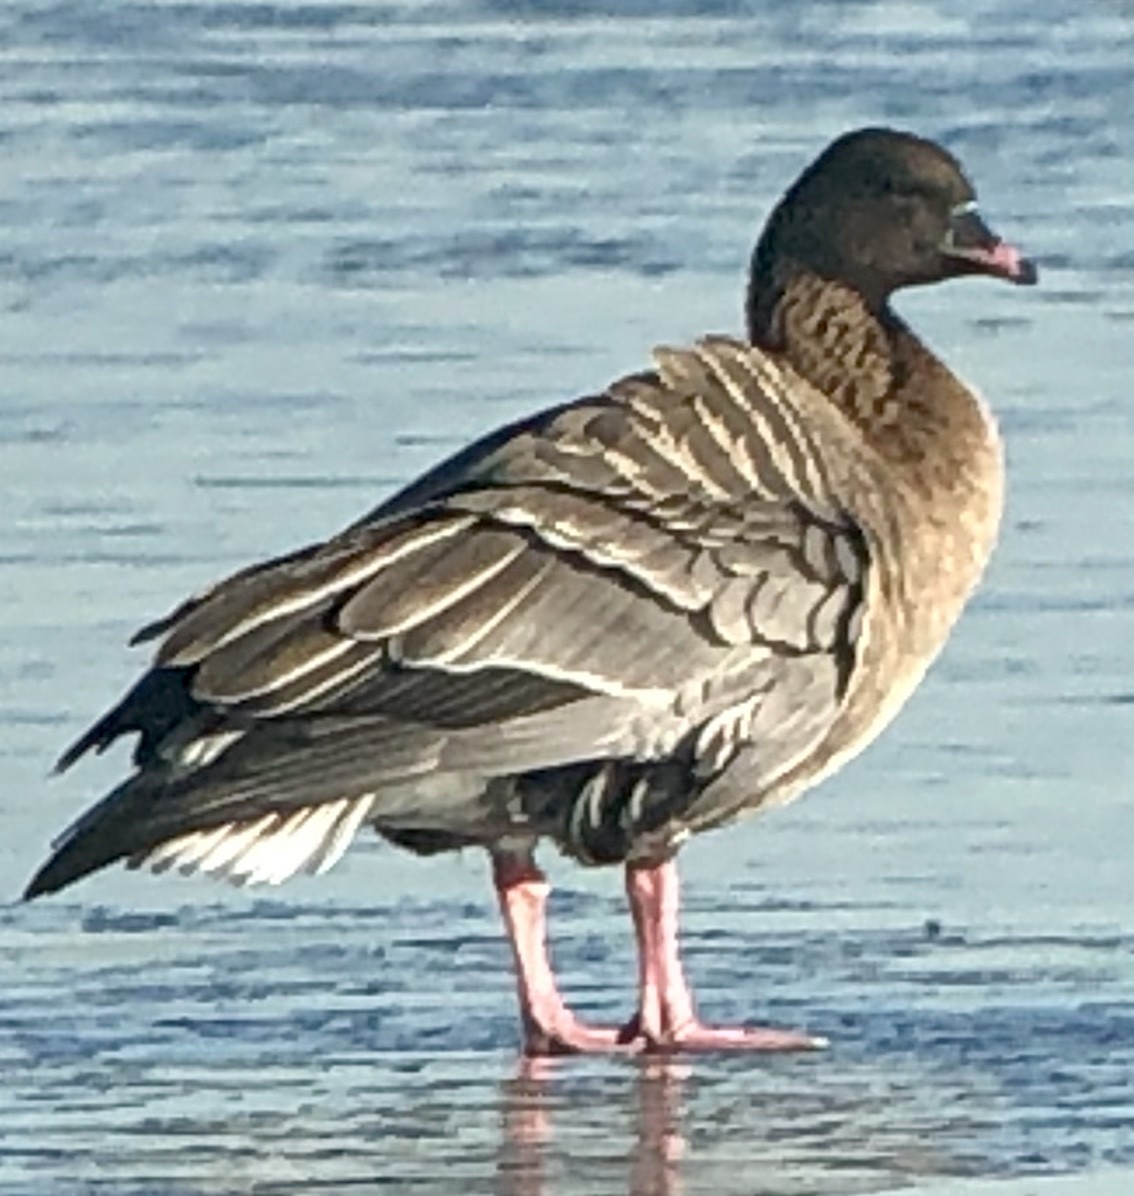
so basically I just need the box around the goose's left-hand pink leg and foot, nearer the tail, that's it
[493,854,627,1055]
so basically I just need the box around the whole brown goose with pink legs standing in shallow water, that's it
[28,129,1035,1050]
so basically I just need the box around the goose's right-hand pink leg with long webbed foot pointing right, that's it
[626,860,827,1051]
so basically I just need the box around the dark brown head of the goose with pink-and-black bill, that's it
[748,129,1036,336]
